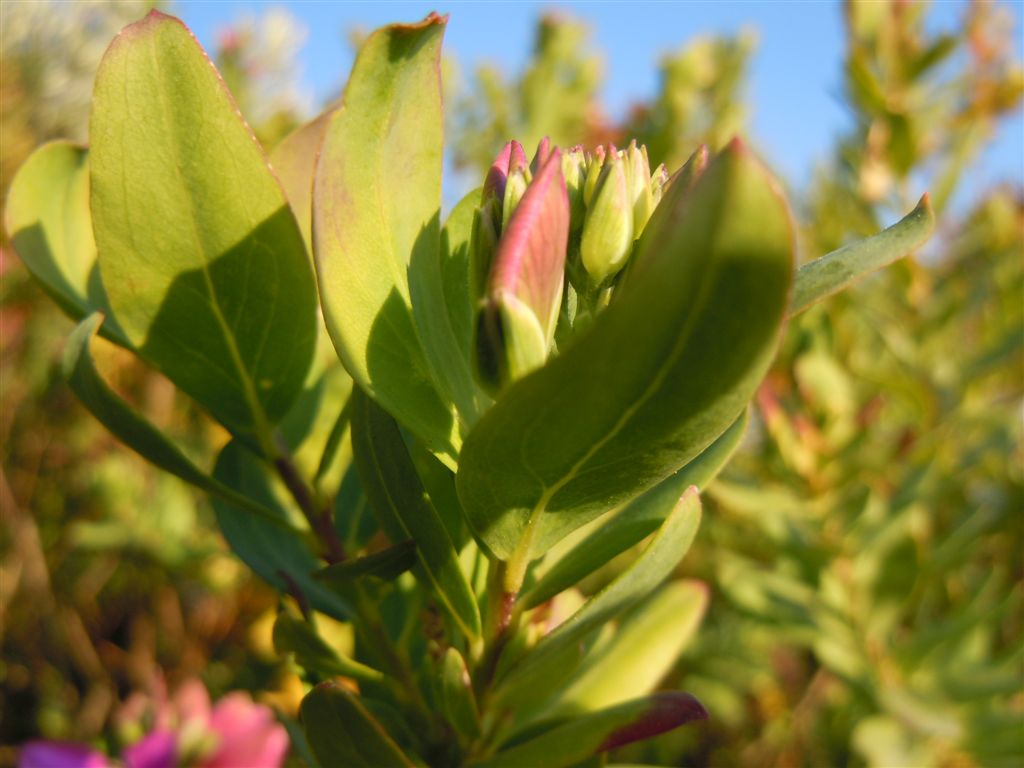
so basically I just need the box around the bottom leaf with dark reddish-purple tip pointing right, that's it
[471,691,708,768]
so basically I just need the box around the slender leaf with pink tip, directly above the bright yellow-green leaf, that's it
[496,487,700,703]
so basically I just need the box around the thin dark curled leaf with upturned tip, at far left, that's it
[63,312,290,535]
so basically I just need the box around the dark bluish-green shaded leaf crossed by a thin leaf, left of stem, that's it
[213,440,351,621]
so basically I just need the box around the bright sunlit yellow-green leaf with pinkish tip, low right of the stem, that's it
[544,581,708,718]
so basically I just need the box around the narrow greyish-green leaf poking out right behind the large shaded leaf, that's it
[790,195,935,316]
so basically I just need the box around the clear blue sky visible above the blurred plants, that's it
[171,0,1024,204]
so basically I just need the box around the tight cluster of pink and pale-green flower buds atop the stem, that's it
[470,138,669,393]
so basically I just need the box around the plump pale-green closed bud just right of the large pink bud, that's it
[580,152,633,286]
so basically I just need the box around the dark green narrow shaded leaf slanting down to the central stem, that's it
[352,390,480,638]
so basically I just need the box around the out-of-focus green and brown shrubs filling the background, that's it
[0,0,1024,766]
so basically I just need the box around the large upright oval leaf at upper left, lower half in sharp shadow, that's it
[89,11,316,444]
